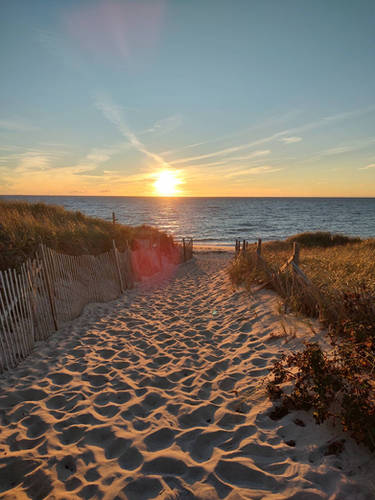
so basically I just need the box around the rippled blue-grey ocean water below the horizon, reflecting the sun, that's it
[2,196,375,246]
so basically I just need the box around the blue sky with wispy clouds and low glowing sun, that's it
[0,0,375,197]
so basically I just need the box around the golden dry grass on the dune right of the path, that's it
[230,233,375,317]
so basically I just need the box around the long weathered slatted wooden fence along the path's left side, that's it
[0,240,193,372]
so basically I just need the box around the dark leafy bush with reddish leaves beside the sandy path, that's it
[267,343,375,451]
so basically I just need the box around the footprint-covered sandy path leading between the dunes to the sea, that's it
[0,252,375,500]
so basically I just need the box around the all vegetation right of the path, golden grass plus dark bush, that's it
[230,233,375,450]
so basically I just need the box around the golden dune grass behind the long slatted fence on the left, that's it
[0,200,173,270]
